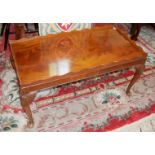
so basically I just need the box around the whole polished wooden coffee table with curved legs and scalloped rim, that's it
[10,26,147,127]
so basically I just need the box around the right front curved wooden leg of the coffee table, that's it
[126,64,145,95]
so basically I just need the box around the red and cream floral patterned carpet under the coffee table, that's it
[0,24,155,131]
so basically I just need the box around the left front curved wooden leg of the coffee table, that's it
[21,93,35,128]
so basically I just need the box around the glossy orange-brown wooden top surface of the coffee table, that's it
[11,28,145,85]
